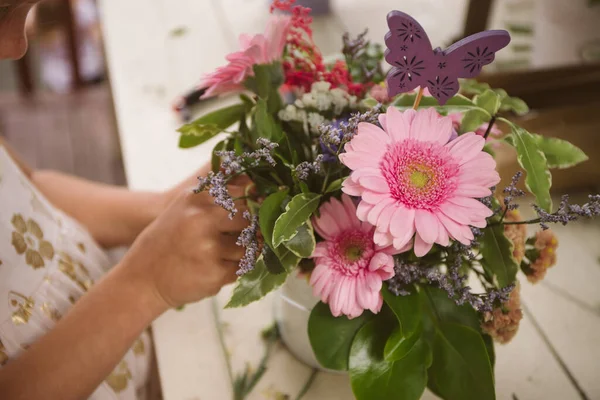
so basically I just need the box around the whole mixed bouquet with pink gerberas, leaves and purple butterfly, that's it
[179,0,600,400]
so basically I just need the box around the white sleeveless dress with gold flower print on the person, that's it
[0,145,151,400]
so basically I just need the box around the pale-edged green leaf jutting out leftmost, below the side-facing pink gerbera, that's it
[177,104,246,149]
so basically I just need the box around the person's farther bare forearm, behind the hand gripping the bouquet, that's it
[31,170,166,247]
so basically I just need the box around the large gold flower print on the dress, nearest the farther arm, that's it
[11,214,54,269]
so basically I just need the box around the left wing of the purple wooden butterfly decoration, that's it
[385,11,435,97]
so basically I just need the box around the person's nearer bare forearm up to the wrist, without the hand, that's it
[0,265,167,400]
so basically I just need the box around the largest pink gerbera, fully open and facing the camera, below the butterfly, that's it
[340,107,500,257]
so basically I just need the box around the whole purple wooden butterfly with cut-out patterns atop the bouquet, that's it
[385,11,510,104]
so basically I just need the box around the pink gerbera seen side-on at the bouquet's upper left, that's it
[200,15,292,98]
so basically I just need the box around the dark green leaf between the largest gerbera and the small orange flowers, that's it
[479,225,519,287]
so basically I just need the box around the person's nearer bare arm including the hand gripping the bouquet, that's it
[0,181,247,400]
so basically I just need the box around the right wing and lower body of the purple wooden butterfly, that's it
[427,30,510,104]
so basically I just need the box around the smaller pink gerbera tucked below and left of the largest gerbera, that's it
[310,195,397,318]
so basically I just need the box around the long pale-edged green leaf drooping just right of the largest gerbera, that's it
[502,123,552,211]
